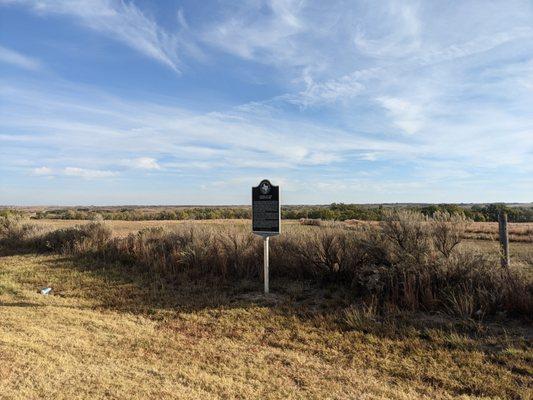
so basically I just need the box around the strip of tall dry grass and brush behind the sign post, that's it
[0,211,533,318]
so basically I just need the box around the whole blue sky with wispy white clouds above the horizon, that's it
[0,0,533,205]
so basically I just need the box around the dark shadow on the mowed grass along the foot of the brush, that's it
[0,244,531,344]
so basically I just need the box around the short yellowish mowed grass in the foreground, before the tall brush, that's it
[0,254,533,399]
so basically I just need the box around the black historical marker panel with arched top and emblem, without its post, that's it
[252,179,281,235]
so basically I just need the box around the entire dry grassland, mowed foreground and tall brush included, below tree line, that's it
[0,215,533,399]
